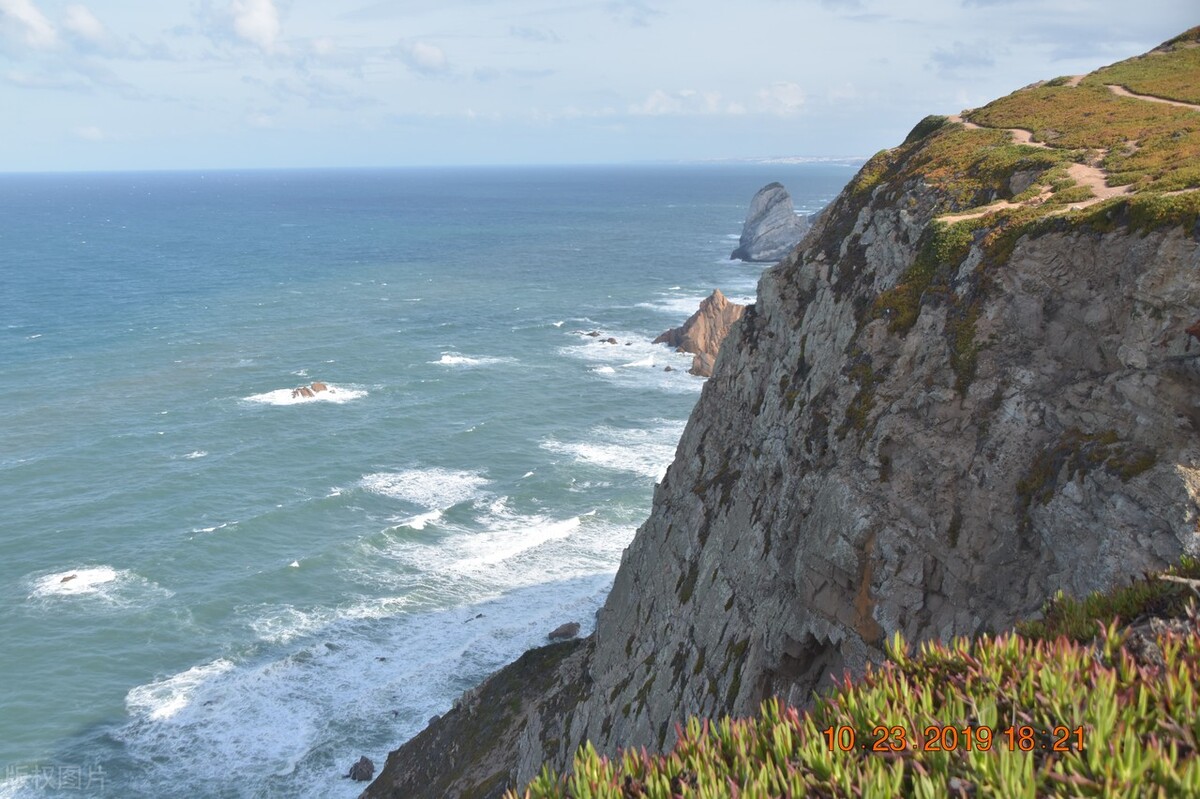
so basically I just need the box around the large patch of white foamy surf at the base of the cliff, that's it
[113,573,619,799]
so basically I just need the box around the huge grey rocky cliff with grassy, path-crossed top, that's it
[365,30,1200,797]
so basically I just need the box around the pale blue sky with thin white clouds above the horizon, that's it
[0,0,1200,172]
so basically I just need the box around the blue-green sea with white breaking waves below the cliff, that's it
[0,164,852,799]
